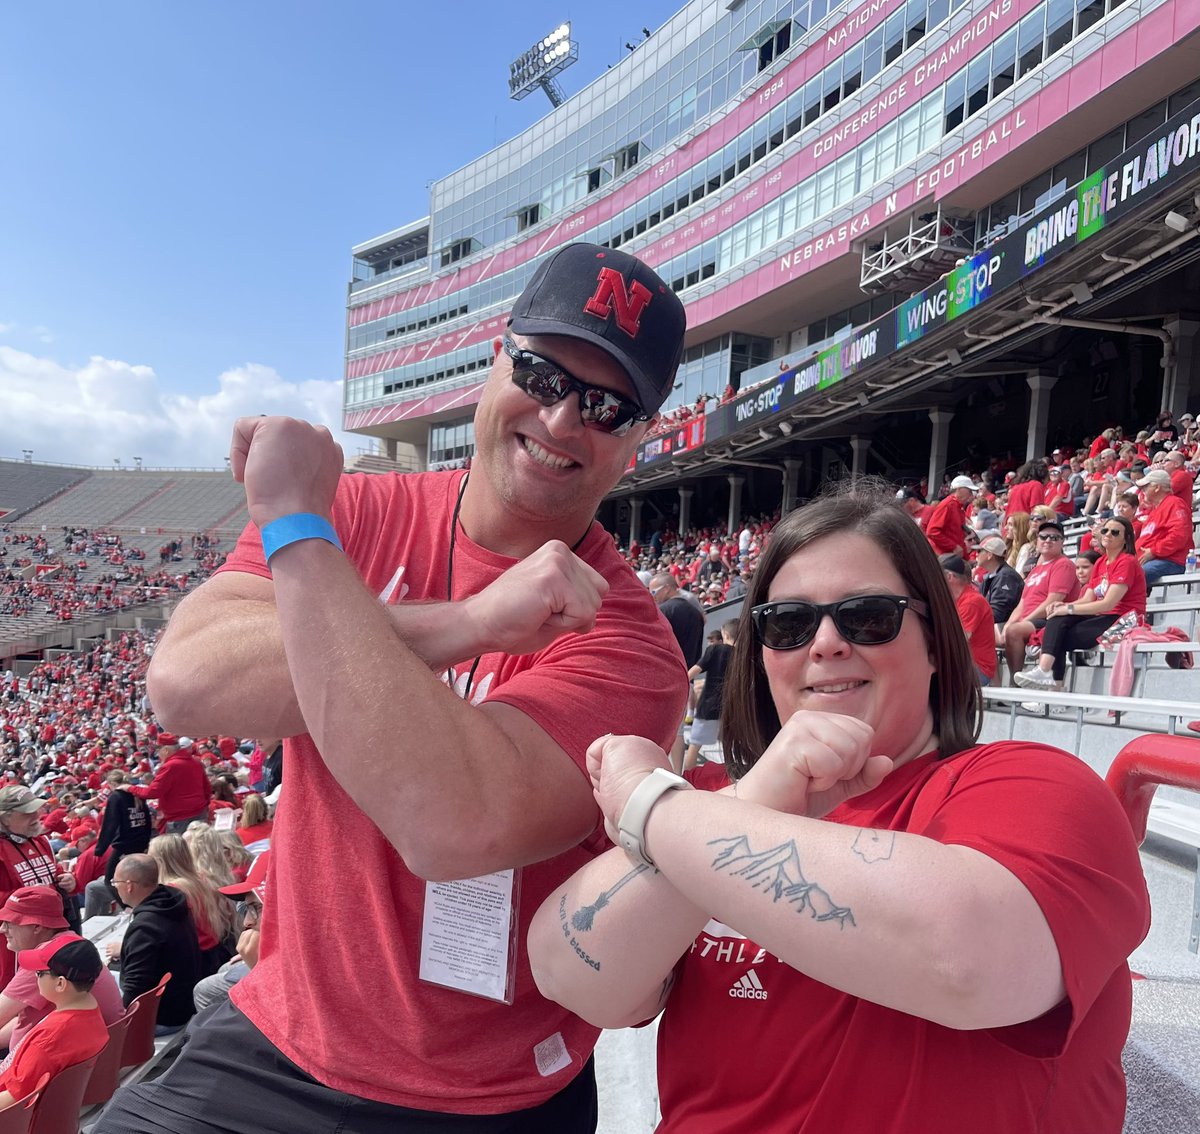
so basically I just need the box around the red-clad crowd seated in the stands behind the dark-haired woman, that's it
[622,408,1200,710]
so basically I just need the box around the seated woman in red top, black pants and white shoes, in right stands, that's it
[1013,516,1146,689]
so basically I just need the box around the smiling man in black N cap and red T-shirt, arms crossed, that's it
[98,244,686,1134]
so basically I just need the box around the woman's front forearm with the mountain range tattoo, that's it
[625,792,1063,1028]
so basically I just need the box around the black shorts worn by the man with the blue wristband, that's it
[92,1001,596,1134]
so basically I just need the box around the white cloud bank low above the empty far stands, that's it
[0,346,360,468]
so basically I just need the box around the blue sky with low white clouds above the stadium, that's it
[0,0,686,467]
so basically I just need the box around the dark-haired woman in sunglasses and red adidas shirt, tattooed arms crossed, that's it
[529,485,1150,1134]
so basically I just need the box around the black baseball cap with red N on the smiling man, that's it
[509,244,688,414]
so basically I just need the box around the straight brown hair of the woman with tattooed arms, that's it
[721,479,983,781]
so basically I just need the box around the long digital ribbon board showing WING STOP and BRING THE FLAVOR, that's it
[631,94,1200,468]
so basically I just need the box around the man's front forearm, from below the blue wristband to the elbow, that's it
[272,540,590,877]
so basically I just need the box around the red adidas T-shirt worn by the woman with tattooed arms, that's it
[658,742,1150,1134]
